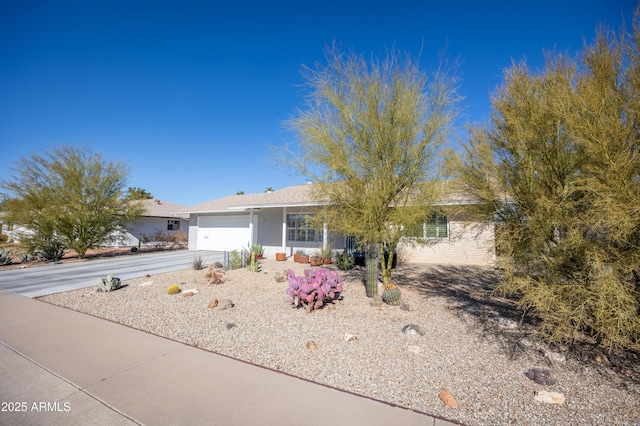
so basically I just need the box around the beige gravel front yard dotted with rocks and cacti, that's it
[40,259,640,425]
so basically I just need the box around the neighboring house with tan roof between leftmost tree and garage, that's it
[118,199,189,247]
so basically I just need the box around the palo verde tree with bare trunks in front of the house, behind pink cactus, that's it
[287,44,457,296]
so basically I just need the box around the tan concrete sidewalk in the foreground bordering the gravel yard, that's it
[0,291,455,426]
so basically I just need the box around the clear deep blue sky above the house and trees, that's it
[0,0,636,206]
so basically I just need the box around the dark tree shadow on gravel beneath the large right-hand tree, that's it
[393,264,640,383]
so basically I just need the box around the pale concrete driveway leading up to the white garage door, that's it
[0,250,224,297]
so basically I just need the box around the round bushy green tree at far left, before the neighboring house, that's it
[1,145,141,259]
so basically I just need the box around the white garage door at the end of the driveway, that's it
[198,215,257,251]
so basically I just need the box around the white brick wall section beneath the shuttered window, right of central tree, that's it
[398,221,496,265]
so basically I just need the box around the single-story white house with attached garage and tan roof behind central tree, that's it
[174,184,495,264]
